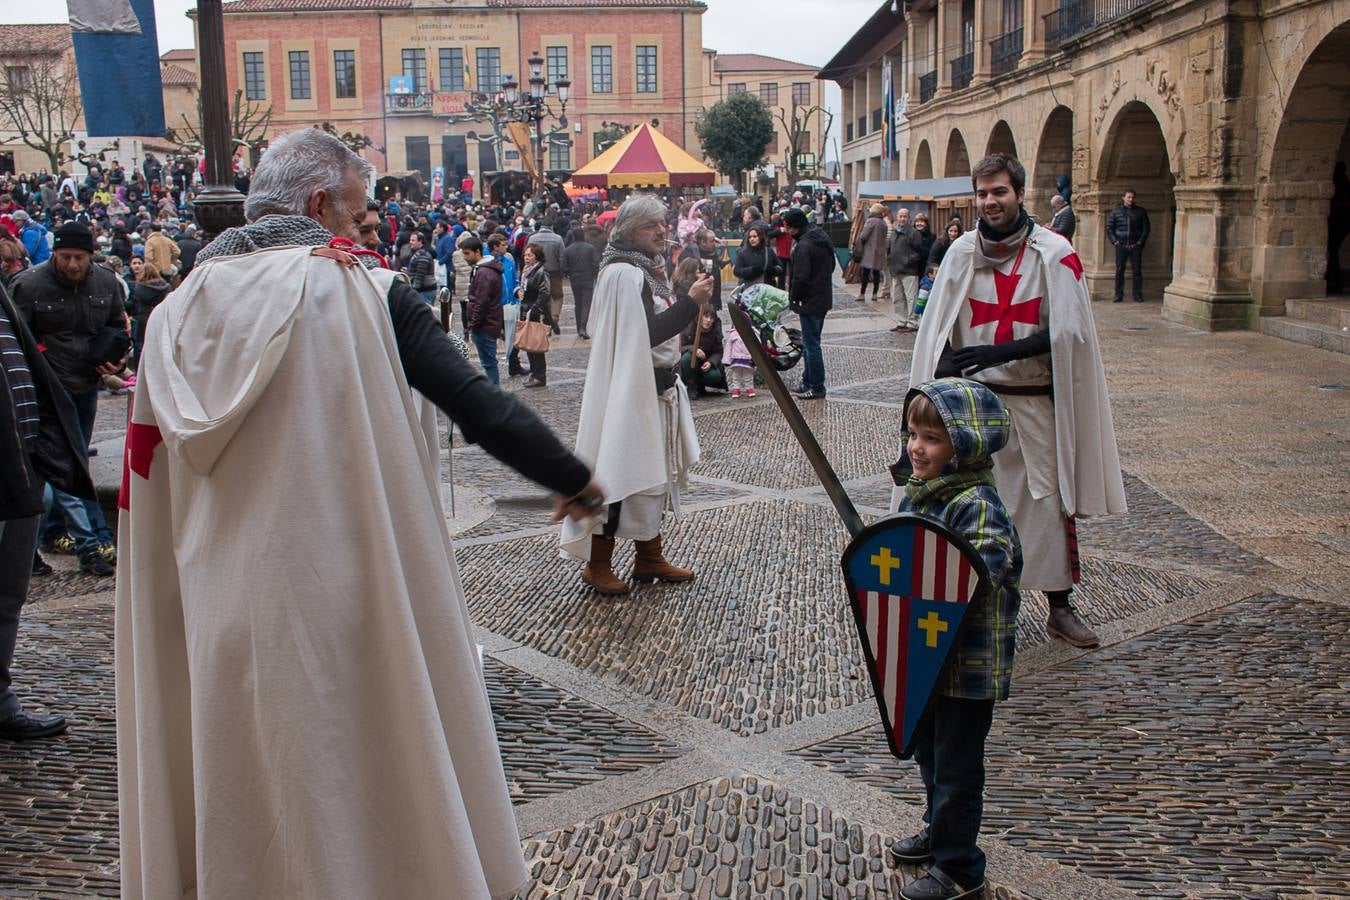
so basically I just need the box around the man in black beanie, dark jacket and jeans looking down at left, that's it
[14,223,127,573]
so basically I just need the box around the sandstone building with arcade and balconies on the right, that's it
[821,0,1350,337]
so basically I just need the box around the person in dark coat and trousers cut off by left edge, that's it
[0,287,96,741]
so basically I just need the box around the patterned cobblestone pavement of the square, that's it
[0,284,1350,899]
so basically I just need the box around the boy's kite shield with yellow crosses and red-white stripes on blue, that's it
[841,513,990,760]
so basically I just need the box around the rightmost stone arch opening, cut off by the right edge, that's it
[1251,22,1350,314]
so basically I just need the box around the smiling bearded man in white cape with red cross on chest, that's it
[892,154,1126,646]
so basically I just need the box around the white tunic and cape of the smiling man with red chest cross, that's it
[891,227,1126,591]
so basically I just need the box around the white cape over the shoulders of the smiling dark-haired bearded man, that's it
[891,227,1126,515]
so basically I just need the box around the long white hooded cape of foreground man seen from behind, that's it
[116,247,528,900]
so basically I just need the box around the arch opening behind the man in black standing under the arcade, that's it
[1092,101,1176,301]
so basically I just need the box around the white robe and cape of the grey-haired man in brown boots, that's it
[560,263,699,560]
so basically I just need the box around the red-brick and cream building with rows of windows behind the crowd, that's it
[209,0,705,184]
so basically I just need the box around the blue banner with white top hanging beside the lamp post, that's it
[70,0,165,138]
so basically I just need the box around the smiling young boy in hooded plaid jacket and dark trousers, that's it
[891,378,1022,900]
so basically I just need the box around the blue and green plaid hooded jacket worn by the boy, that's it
[899,378,1022,700]
